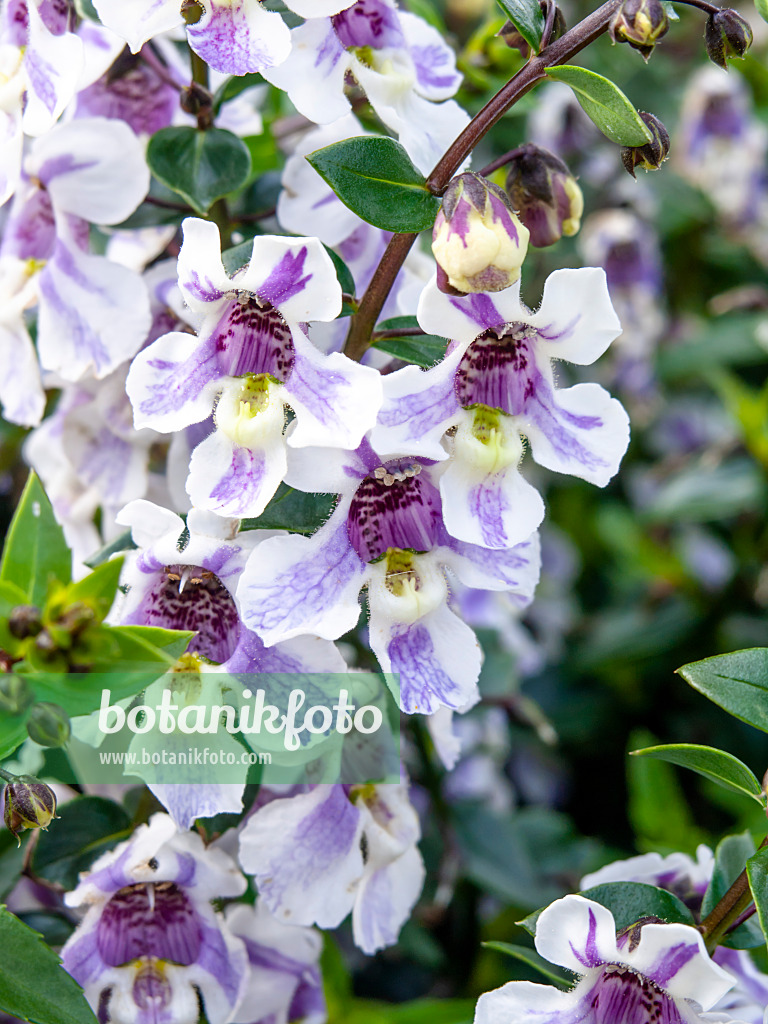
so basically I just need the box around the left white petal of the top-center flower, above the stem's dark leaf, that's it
[264,17,351,124]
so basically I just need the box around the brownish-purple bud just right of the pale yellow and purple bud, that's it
[507,142,584,249]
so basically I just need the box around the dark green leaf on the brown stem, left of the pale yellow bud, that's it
[306,135,440,231]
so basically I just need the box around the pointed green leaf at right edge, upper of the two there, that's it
[677,647,768,732]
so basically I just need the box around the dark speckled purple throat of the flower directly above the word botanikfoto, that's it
[142,565,240,663]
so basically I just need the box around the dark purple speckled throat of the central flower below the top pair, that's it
[347,459,442,562]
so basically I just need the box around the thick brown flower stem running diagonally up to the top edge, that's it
[344,0,622,360]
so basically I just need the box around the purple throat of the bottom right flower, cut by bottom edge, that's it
[586,965,685,1024]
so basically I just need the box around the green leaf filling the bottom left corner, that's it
[0,907,96,1024]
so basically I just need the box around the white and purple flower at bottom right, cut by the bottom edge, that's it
[475,896,733,1024]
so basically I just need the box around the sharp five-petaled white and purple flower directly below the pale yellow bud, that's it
[372,267,629,549]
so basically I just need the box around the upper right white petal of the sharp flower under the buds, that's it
[526,267,622,366]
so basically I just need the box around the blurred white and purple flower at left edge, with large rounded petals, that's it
[0,118,152,425]
